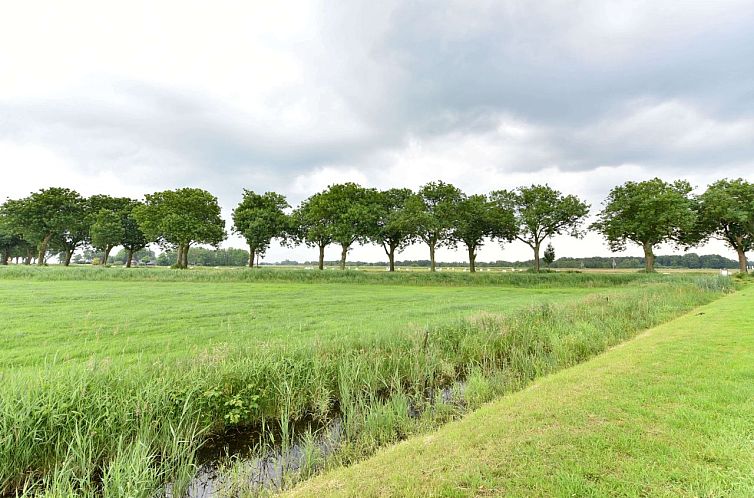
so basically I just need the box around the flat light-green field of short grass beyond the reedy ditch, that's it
[0,279,595,375]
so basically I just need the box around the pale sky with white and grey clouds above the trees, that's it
[0,0,754,261]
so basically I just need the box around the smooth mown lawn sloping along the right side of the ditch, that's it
[284,287,754,497]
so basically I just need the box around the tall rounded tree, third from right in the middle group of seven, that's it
[405,181,463,271]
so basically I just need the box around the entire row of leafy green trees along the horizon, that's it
[0,178,754,272]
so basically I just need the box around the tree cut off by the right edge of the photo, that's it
[695,178,754,273]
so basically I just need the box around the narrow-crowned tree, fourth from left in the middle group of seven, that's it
[370,188,414,271]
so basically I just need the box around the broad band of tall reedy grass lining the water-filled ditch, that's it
[0,272,731,496]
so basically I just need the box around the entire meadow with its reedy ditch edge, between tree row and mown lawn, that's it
[0,267,733,496]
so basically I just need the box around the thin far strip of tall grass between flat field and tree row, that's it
[0,265,668,288]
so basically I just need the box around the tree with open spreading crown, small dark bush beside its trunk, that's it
[491,185,589,271]
